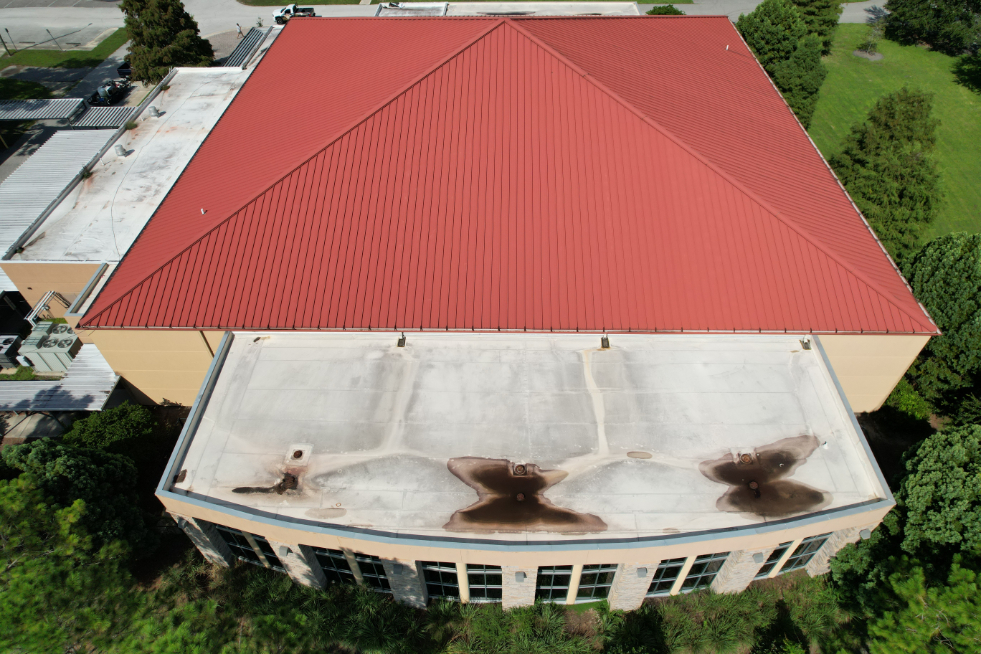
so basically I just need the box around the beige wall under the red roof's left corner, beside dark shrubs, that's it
[76,329,224,406]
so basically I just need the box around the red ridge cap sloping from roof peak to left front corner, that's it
[78,18,507,327]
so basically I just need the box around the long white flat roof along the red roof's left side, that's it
[11,68,251,262]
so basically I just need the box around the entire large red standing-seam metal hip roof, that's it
[81,17,937,333]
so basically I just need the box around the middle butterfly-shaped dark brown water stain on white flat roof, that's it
[443,456,606,534]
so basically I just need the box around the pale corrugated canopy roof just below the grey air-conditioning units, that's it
[0,343,119,411]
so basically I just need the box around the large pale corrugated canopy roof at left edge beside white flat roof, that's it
[0,130,115,253]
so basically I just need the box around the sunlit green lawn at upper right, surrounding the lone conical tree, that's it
[810,24,981,238]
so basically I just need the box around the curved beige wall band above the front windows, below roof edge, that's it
[158,495,892,567]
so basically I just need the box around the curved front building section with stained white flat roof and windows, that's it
[158,332,893,609]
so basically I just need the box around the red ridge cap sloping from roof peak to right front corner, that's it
[506,18,936,332]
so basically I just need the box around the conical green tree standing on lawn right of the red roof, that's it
[830,88,941,262]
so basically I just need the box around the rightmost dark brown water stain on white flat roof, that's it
[698,434,831,518]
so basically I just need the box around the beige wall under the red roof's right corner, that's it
[820,334,930,413]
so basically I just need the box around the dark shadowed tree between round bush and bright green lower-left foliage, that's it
[2,439,156,555]
